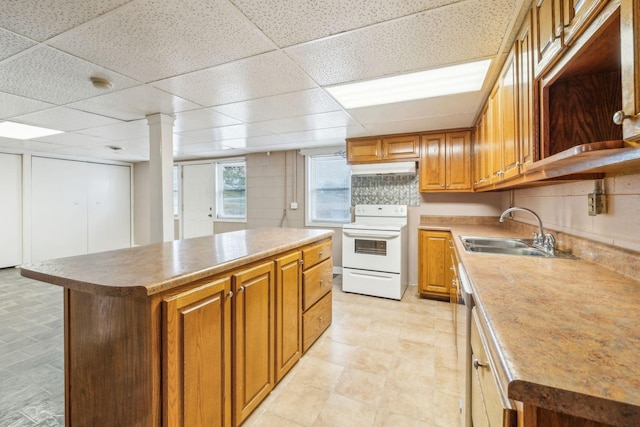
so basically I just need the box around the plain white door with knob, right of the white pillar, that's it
[182,163,215,239]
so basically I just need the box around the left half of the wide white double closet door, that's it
[31,157,87,261]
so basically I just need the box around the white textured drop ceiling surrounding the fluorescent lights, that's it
[0,0,531,162]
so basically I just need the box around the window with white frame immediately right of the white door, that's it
[216,161,247,221]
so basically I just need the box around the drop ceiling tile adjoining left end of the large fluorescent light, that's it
[214,89,341,123]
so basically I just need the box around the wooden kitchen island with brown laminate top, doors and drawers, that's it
[21,228,333,427]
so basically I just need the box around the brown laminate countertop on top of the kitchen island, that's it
[20,228,334,297]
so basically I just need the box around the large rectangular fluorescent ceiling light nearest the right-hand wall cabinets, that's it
[327,59,491,108]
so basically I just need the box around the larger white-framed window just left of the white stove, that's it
[307,154,351,226]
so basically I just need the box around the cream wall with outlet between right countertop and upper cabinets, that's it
[502,174,640,251]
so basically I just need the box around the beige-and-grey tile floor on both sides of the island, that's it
[0,269,460,427]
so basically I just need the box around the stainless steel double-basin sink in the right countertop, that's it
[460,236,576,259]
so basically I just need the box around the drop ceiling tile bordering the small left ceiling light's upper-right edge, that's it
[13,107,121,132]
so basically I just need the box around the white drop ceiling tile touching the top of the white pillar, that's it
[70,85,200,120]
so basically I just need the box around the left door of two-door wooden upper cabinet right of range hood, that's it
[420,133,446,191]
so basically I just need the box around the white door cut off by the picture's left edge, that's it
[0,153,22,268]
